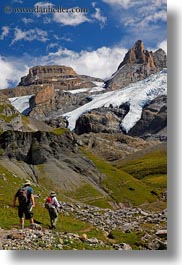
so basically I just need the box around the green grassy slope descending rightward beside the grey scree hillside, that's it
[82,148,156,205]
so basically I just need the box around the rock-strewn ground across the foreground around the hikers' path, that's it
[0,202,167,250]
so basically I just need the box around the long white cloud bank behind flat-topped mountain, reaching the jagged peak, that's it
[0,45,127,89]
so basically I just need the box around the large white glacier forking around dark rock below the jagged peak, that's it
[63,69,167,132]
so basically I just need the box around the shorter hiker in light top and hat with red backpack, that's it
[45,191,60,229]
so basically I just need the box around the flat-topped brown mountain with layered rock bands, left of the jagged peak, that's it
[0,65,103,98]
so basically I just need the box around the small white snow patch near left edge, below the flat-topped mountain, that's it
[9,95,33,113]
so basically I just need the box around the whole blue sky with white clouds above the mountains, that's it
[0,0,167,89]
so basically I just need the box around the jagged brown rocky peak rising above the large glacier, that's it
[105,40,167,90]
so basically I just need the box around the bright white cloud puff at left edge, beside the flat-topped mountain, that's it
[0,56,28,89]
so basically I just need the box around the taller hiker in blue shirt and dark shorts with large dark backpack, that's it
[13,180,35,229]
